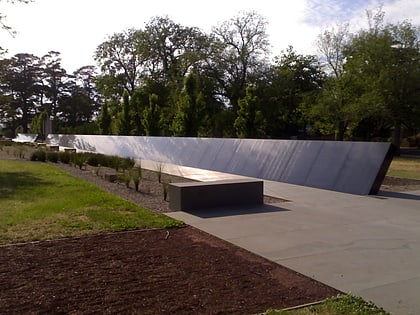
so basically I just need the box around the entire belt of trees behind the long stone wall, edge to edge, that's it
[0,10,420,151]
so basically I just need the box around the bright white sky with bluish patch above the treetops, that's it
[0,0,420,73]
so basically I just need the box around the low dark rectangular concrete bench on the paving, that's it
[168,179,264,211]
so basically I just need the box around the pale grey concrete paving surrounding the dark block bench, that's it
[142,161,420,315]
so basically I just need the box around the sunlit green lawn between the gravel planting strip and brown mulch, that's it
[0,160,181,244]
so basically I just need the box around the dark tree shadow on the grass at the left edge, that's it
[0,172,51,199]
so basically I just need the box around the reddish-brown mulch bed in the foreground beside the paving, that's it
[0,227,339,314]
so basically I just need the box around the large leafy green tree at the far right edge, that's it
[346,12,420,148]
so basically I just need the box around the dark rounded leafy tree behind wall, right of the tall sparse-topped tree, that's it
[266,46,325,138]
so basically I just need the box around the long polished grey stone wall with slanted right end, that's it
[46,135,392,195]
